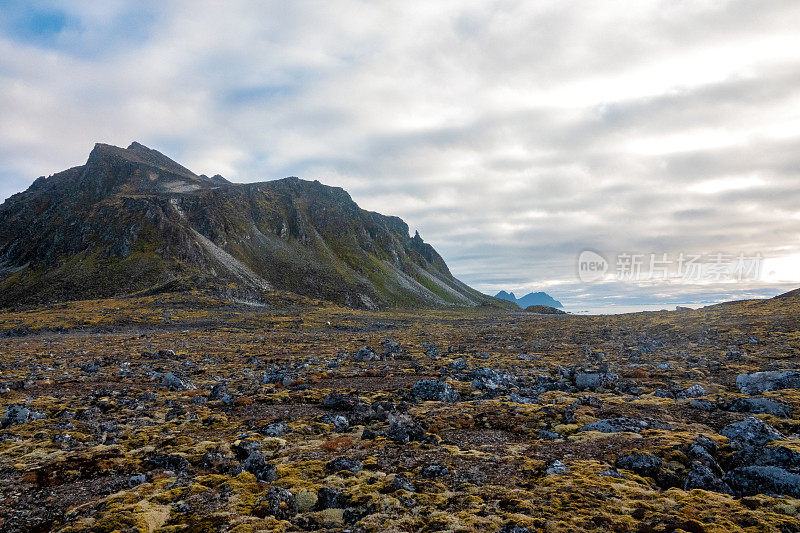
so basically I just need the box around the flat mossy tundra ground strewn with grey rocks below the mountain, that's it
[0,292,800,533]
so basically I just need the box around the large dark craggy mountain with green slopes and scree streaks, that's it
[0,142,510,308]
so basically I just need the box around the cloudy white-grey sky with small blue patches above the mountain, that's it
[0,0,800,312]
